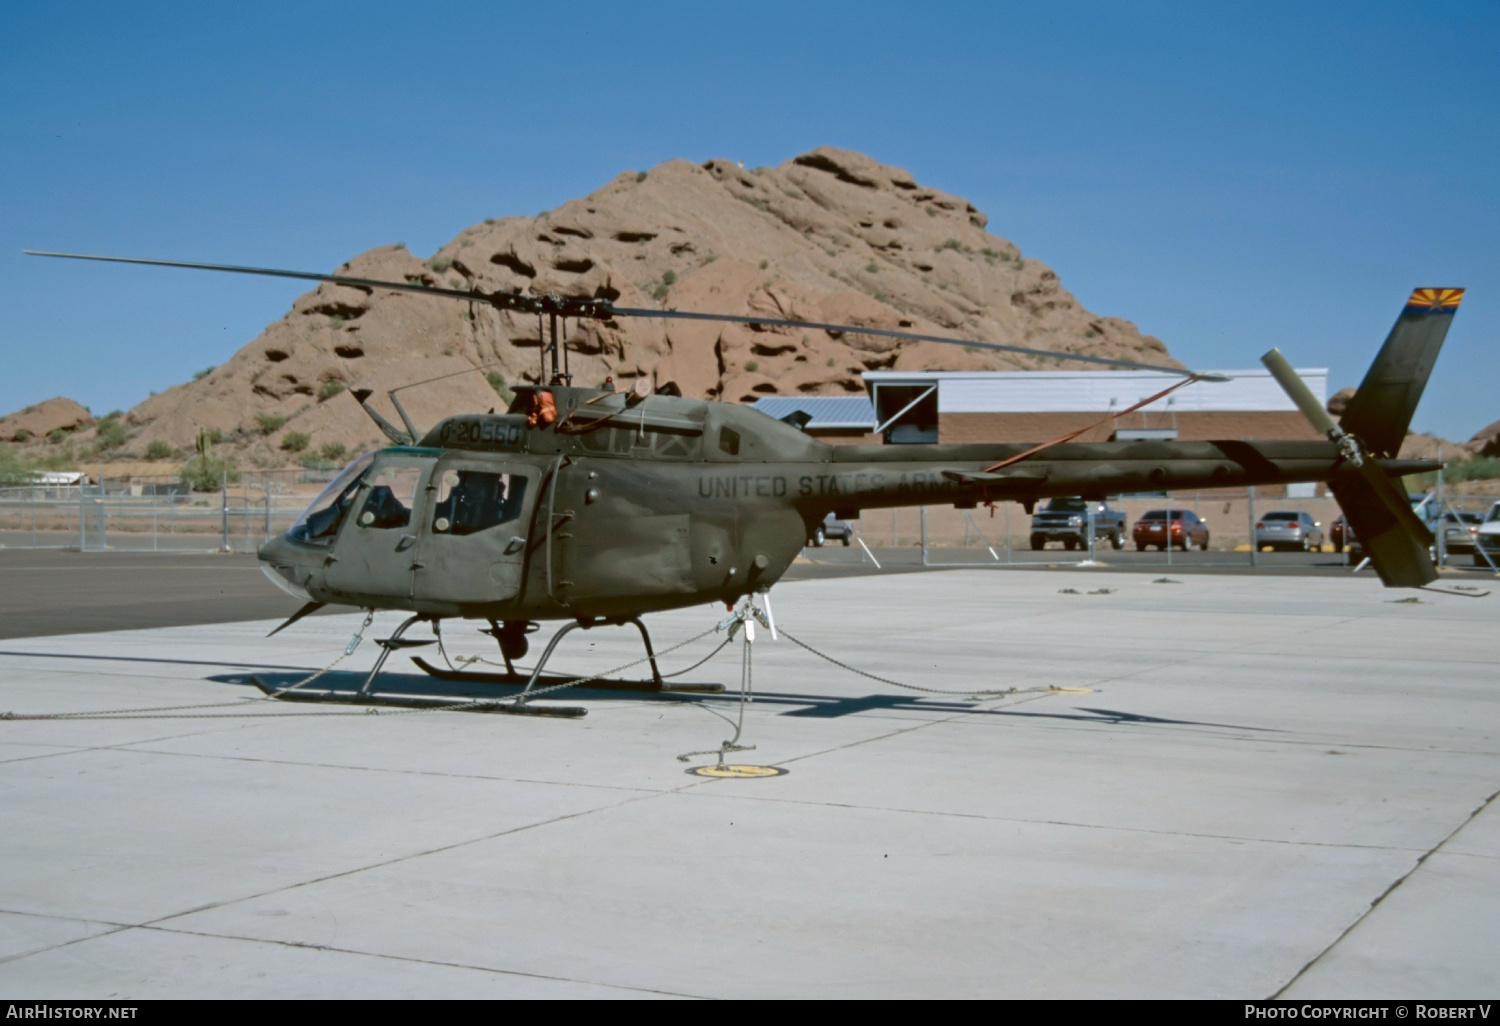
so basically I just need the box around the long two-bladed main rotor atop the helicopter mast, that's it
[23,249,1229,381]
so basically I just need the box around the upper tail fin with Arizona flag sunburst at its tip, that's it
[1340,288,1464,458]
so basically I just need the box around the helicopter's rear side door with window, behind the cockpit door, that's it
[416,456,537,605]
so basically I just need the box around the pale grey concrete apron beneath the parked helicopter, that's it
[0,570,1500,998]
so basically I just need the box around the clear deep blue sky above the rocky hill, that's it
[0,0,1500,440]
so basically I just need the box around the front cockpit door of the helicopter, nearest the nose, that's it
[326,453,432,608]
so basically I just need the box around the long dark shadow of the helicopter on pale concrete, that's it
[206,671,1280,734]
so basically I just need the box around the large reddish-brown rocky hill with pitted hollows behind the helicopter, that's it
[14,149,1170,465]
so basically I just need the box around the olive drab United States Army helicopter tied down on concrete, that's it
[27,251,1464,711]
